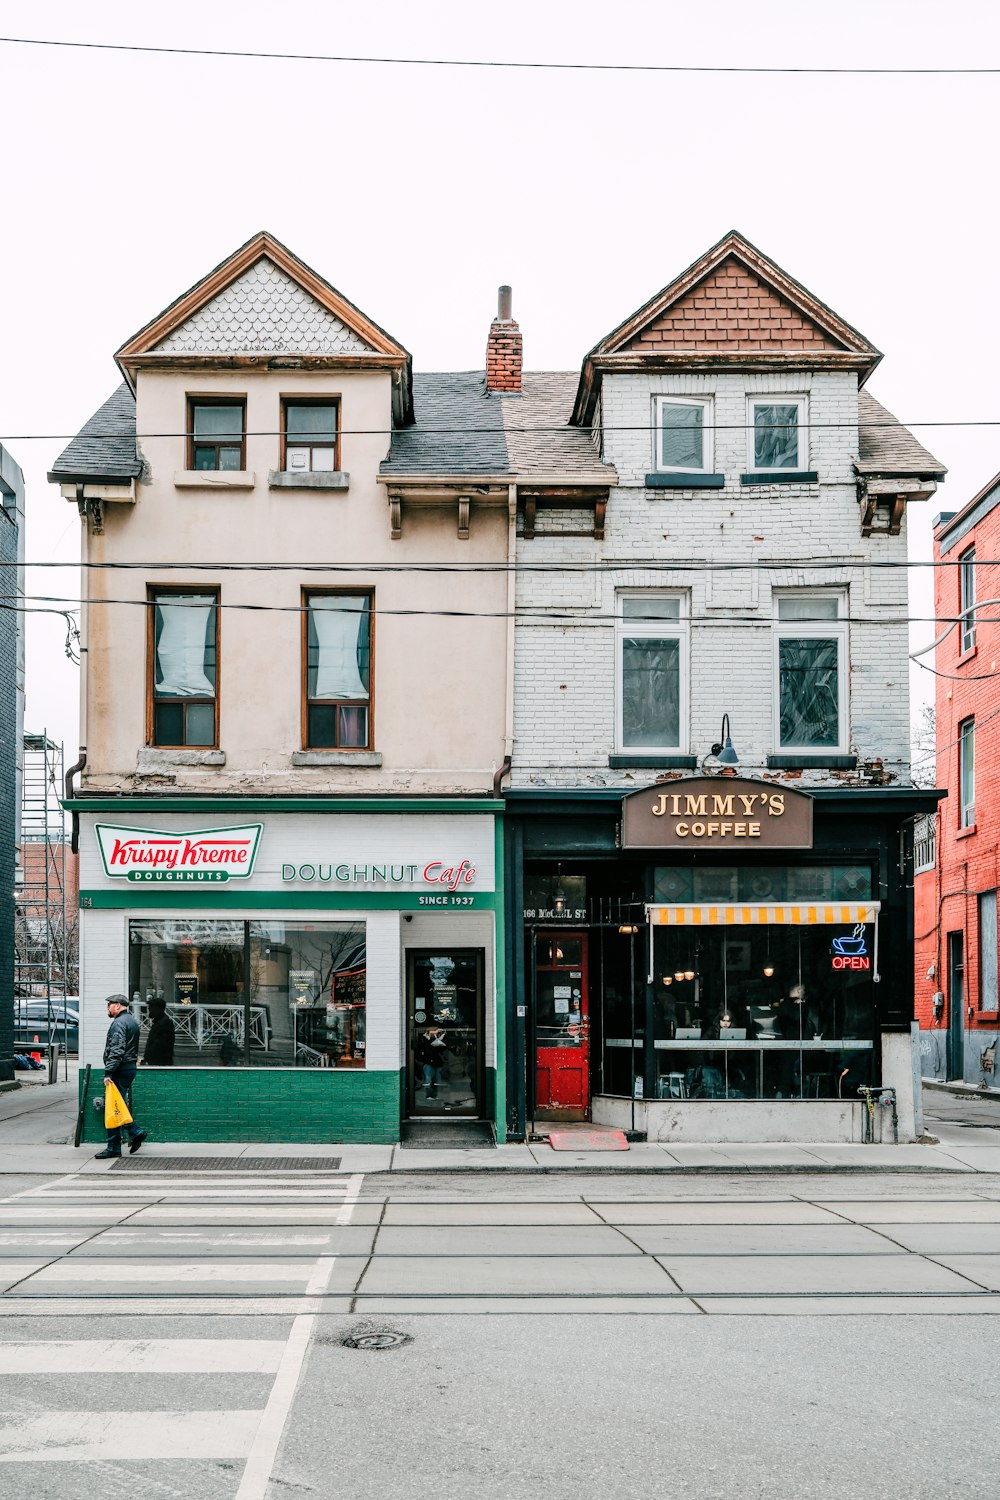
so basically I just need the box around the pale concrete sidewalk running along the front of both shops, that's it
[0,1083,1000,1181]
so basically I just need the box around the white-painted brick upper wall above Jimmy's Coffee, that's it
[513,372,909,786]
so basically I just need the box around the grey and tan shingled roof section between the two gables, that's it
[381,371,618,485]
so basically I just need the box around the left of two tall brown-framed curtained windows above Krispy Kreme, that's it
[147,590,219,750]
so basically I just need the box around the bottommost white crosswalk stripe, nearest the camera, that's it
[0,1410,261,1464]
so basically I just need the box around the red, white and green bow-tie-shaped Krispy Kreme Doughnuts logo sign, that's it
[96,824,264,885]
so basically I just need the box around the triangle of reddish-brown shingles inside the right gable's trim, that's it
[630,257,840,354]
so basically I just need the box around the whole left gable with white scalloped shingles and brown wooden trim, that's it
[115,230,412,423]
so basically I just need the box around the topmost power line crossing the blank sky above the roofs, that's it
[0,36,1000,78]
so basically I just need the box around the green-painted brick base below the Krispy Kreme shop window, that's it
[79,1068,400,1146]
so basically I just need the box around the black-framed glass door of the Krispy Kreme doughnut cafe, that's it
[406,948,484,1119]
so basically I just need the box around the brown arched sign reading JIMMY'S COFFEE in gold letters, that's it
[622,776,813,851]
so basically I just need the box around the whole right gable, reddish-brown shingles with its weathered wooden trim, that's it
[573,230,882,425]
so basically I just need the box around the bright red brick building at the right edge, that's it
[913,474,1000,1086]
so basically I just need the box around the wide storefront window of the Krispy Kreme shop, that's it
[129,917,366,1068]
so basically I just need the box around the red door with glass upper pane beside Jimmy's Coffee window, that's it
[535,932,591,1121]
